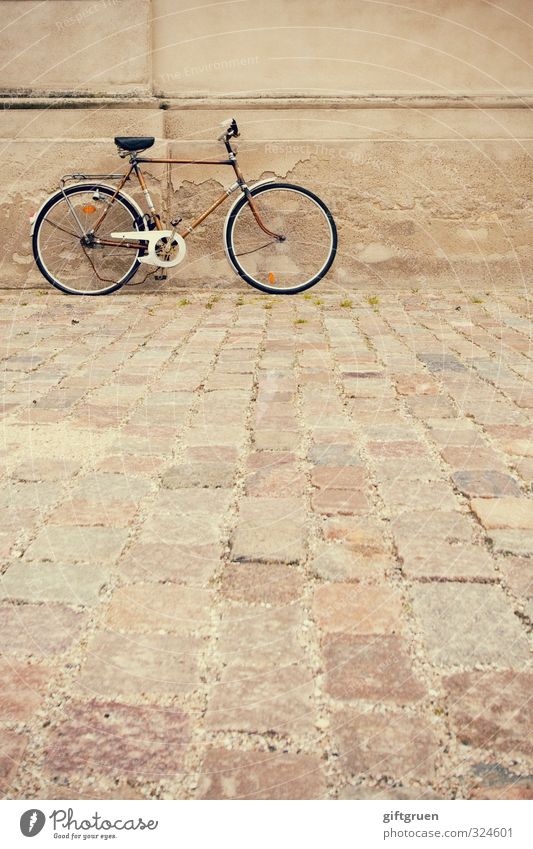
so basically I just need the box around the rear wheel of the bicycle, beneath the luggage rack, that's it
[32,184,145,295]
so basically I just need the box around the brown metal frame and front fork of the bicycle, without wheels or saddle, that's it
[92,155,283,250]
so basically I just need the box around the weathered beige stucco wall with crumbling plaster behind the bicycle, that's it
[0,0,533,289]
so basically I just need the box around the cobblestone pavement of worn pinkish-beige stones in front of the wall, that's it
[0,290,533,799]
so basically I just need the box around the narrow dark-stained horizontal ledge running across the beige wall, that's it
[0,95,533,110]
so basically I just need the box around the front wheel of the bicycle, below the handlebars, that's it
[225,183,337,295]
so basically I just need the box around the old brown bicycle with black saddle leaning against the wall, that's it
[31,118,337,295]
